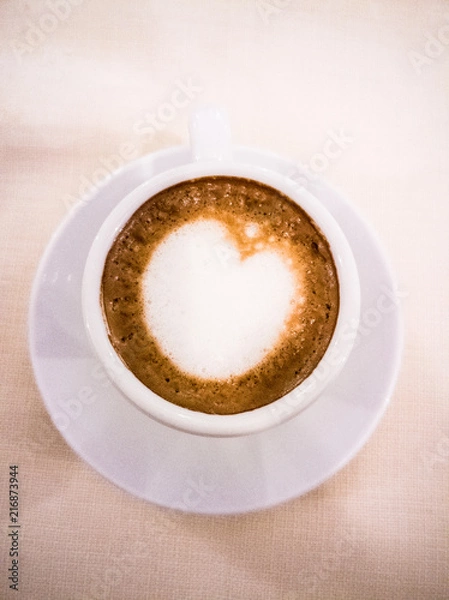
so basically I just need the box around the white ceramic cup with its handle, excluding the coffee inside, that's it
[82,107,360,437]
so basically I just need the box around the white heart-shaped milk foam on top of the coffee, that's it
[143,219,298,379]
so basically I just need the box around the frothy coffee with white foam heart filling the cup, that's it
[102,176,339,414]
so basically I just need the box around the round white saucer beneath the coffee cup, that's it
[30,148,402,514]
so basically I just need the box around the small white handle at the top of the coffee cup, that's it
[189,106,232,162]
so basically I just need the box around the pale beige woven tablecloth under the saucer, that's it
[0,0,449,600]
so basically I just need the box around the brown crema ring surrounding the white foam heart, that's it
[101,176,339,414]
